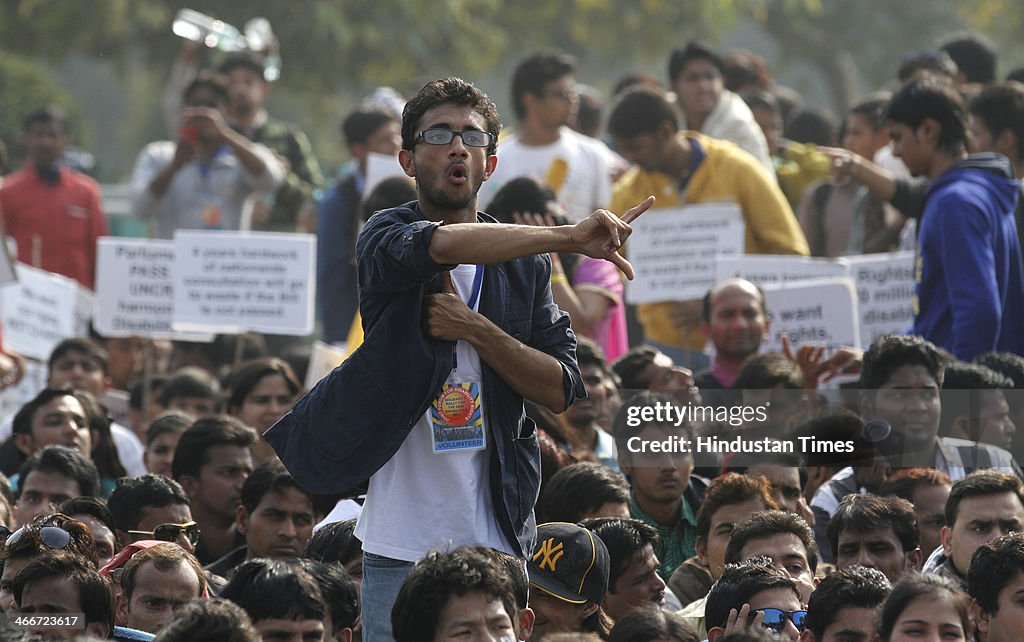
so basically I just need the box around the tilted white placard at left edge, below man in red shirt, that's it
[0,263,91,360]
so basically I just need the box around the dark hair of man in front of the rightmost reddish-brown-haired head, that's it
[828,494,921,556]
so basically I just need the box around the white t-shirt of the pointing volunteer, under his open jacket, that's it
[355,265,515,562]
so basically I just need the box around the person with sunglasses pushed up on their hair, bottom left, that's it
[0,513,96,613]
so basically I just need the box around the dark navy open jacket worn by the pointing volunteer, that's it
[265,202,586,555]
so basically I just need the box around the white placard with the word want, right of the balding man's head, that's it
[761,277,860,352]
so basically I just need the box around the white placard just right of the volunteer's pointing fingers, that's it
[626,203,745,303]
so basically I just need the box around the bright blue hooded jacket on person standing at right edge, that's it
[913,154,1024,360]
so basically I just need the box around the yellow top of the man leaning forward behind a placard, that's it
[609,131,810,350]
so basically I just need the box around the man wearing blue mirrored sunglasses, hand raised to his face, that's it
[705,558,807,642]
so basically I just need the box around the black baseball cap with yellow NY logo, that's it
[528,522,611,604]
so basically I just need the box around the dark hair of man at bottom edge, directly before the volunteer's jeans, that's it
[391,547,516,642]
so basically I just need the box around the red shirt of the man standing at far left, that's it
[0,165,108,290]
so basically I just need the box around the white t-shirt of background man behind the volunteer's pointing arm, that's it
[477,127,611,221]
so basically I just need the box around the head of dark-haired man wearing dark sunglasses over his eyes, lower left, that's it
[106,474,200,553]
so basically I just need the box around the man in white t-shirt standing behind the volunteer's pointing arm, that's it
[480,51,612,221]
